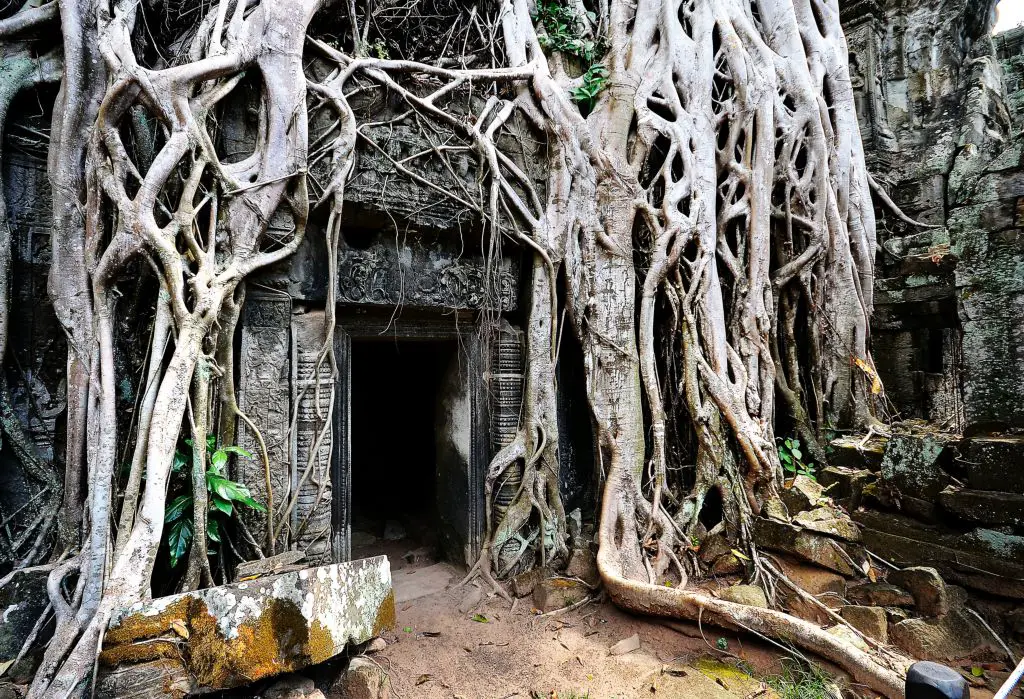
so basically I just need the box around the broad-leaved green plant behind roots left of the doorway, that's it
[164,435,266,568]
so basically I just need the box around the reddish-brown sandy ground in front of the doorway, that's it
[371,564,802,699]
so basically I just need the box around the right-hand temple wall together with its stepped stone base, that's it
[839,0,1024,643]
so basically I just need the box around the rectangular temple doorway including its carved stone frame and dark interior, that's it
[332,311,489,565]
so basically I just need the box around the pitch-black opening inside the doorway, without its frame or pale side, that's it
[351,340,458,569]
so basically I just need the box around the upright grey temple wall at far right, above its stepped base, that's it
[842,0,1024,432]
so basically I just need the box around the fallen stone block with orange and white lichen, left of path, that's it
[100,557,395,697]
